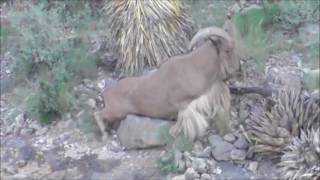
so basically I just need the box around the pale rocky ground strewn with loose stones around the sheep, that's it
[0,46,310,180]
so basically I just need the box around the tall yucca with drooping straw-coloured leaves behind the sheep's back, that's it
[106,0,191,75]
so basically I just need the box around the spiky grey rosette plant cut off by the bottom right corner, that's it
[278,128,320,180]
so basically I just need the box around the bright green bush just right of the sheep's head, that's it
[233,2,280,68]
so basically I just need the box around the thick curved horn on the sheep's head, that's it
[189,27,233,50]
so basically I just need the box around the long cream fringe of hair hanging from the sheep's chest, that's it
[170,81,231,140]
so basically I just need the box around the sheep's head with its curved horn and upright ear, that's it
[189,18,240,79]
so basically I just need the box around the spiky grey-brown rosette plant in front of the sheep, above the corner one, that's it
[247,90,320,158]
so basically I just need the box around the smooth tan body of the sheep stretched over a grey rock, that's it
[95,17,239,137]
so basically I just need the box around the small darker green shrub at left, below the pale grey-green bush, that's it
[28,64,74,123]
